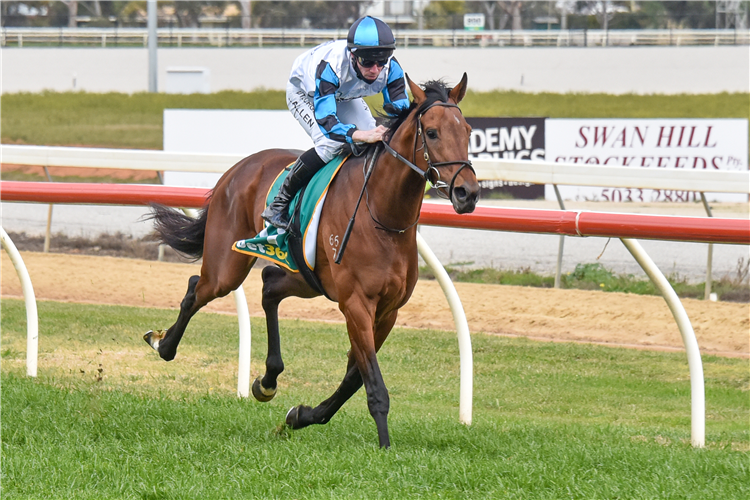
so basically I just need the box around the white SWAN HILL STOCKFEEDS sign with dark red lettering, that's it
[545,118,748,202]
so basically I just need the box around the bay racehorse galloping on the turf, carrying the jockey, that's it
[144,73,480,448]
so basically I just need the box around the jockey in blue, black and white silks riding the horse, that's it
[261,16,409,230]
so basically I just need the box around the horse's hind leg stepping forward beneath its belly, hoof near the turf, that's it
[252,266,319,402]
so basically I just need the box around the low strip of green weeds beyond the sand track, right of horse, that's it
[419,261,750,302]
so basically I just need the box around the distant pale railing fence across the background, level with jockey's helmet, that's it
[0,28,750,48]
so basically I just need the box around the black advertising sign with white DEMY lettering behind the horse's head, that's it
[466,118,545,200]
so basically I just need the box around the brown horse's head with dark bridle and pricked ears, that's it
[406,73,479,214]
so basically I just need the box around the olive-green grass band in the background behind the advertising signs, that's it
[0,90,750,149]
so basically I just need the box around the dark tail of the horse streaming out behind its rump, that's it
[144,203,208,260]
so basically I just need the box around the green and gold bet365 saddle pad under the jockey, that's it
[232,155,347,272]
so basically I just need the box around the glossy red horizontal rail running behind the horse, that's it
[0,181,750,245]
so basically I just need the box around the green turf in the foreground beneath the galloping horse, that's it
[0,299,750,499]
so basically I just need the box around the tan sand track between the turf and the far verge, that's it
[0,252,750,357]
